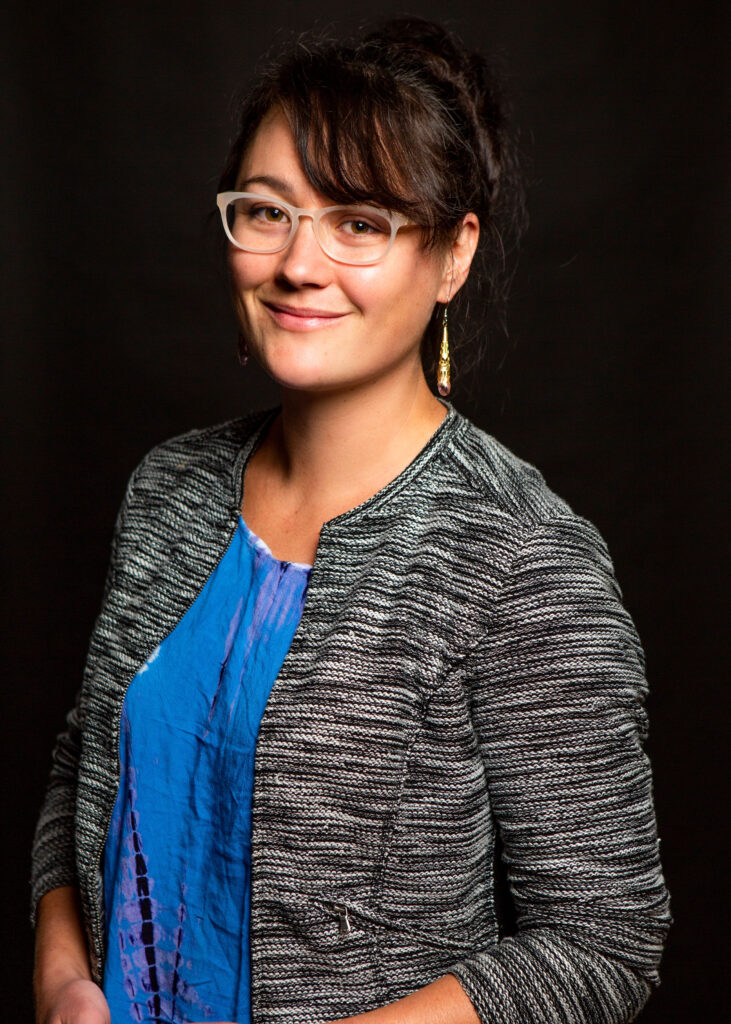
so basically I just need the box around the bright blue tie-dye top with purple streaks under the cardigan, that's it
[103,517,310,1024]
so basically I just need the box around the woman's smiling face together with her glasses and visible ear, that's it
[221,105,479,419]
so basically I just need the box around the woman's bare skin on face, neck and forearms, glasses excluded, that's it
[34,110,479,1024]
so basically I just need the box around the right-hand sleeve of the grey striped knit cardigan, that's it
[449,513,672,1024]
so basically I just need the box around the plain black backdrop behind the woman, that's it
[0,0,727,1024]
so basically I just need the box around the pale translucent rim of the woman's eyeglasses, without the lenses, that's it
[216,191,412,266]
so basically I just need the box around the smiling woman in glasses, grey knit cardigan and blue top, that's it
[33,20,670,1024]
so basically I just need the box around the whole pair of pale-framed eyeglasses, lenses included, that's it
[216,191,410,266]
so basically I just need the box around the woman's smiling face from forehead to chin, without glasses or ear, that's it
[229,110,466,390]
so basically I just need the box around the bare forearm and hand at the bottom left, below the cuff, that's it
[33,886,111,1024]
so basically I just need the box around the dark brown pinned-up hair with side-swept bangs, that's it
[219,17,524,391]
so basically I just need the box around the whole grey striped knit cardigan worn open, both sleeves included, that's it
[32,401,671,1024]
